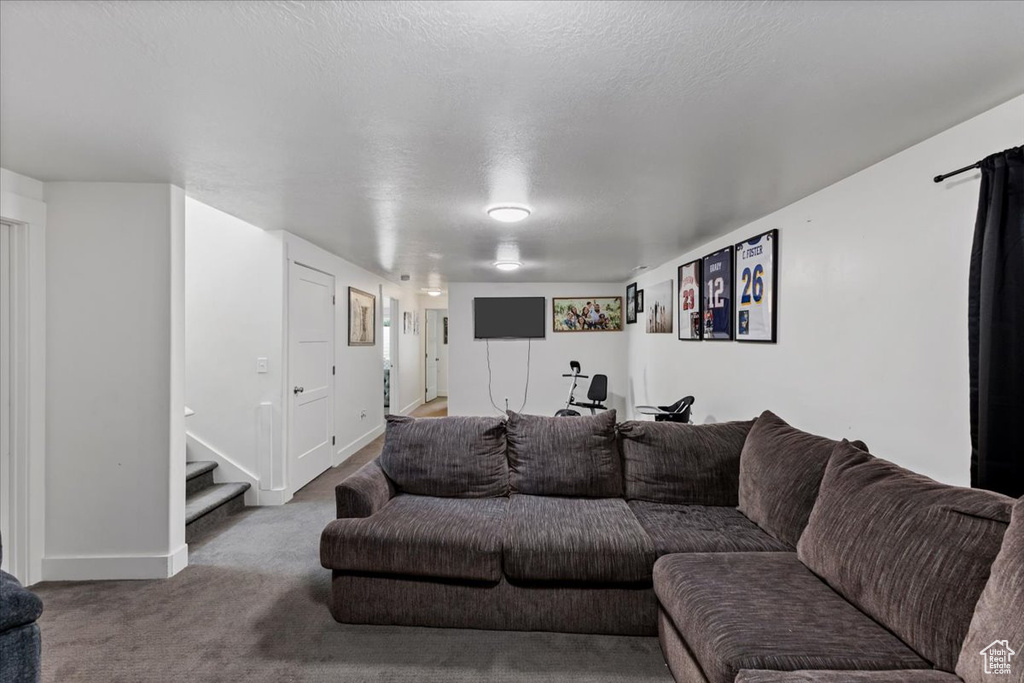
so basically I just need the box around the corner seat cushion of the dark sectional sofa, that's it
[629,501,796,557]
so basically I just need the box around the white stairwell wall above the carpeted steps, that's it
[185,199,286,505]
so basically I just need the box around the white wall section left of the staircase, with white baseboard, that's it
[43,182,187,580]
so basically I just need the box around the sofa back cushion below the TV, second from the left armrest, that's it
[507,411,623,498]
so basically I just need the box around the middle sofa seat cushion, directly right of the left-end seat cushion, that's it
[504,495,654,583]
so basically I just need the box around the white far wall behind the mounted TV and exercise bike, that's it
[449,283,628,415]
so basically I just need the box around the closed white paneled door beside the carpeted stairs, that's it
[288,263,334,492]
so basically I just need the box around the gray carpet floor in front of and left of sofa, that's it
[34,401,672,683]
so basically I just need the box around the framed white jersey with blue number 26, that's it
[734,229,778,344]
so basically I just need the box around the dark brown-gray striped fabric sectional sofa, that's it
[321,411,1024,683]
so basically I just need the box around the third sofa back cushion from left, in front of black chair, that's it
[618,420,754,507]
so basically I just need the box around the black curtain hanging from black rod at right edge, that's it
[968,146,1024,498]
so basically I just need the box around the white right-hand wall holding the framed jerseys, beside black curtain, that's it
[628,96,1024,485]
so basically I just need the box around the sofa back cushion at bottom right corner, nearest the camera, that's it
[956,498,1024,683]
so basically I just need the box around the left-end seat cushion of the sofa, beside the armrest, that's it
[321,494,508,583]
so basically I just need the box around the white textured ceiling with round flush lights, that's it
[0,1,1024,286]
